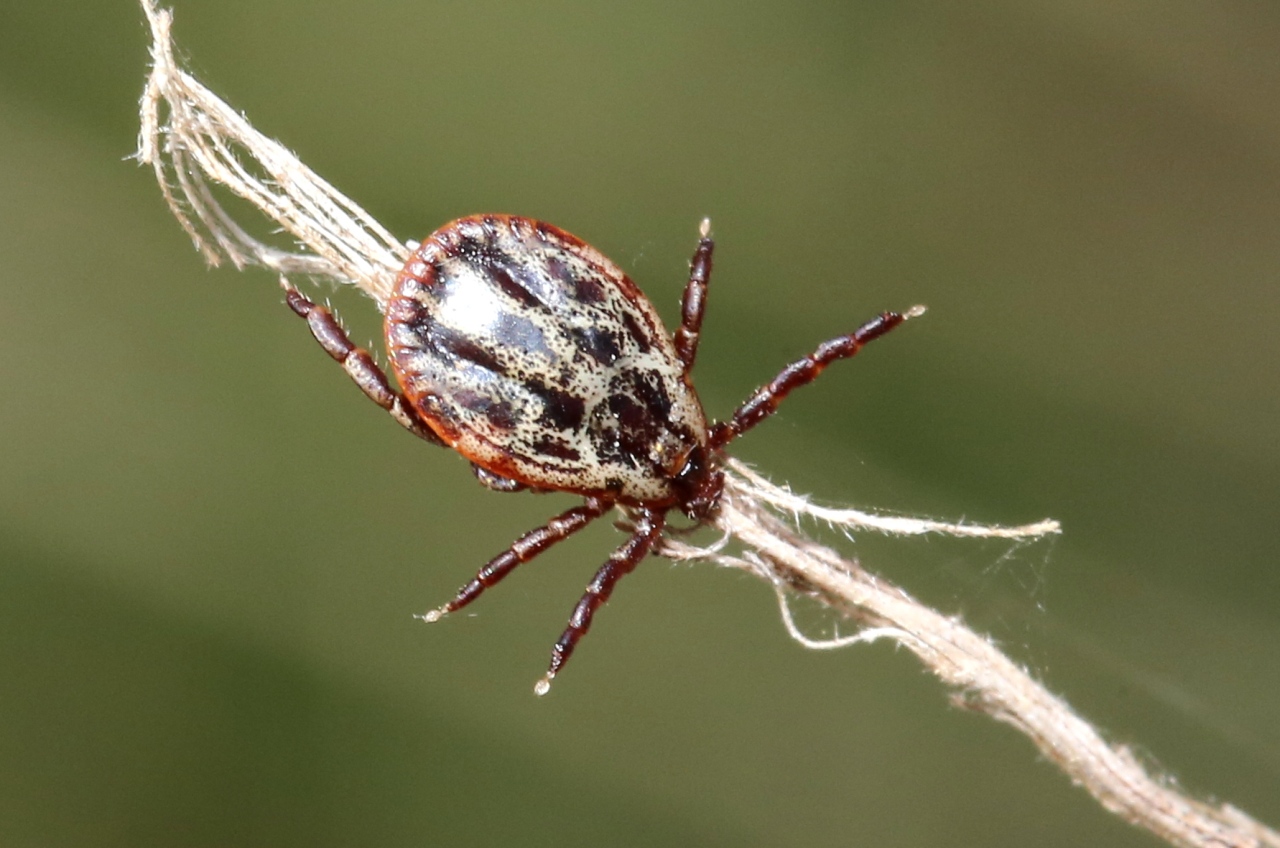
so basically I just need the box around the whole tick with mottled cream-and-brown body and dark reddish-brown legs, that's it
[285,215,924,694]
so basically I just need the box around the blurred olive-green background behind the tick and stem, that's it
[0,0,1280,845]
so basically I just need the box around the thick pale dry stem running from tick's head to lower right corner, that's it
[664,464,1280,848]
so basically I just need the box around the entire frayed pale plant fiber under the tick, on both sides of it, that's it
[137,0,1280,848]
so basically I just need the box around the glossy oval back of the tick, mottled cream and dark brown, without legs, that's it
[385,215,707,506]
